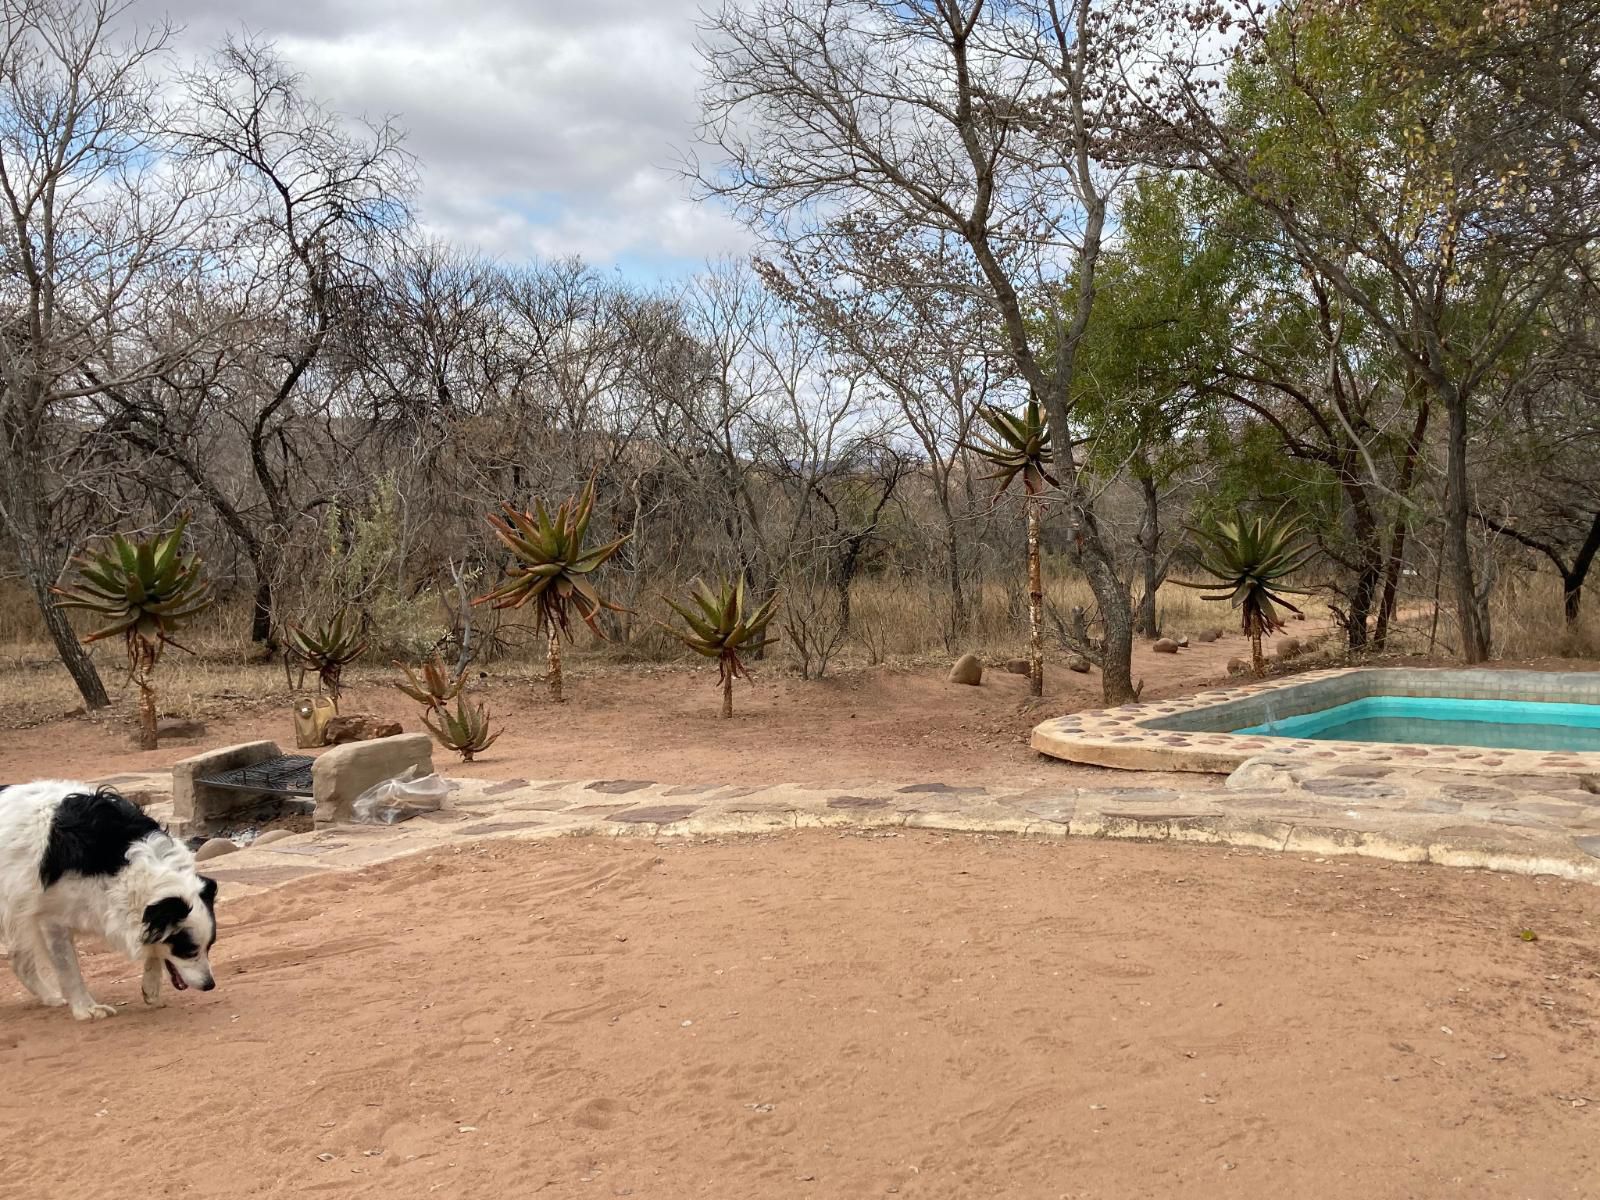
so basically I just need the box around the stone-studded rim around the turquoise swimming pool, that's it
[1032,667,1600,774]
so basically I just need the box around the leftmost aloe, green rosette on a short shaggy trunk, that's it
[54,517,211,750]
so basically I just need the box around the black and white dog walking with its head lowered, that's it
[0,779,216,1021]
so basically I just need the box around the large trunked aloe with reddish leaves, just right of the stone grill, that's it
[472,478,627,704]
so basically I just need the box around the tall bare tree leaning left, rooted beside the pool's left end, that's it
[696,0,1133,702]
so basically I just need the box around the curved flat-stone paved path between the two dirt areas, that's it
[102,757,1600,896]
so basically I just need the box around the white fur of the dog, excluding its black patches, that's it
[0,779,216,1021]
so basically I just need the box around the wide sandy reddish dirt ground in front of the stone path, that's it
[0,834,1600,1200]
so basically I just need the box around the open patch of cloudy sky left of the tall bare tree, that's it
[151,0,747,278]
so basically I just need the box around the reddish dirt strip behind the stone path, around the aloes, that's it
[0,622,1350,786]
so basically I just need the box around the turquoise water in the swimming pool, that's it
[1234,696,1600,750]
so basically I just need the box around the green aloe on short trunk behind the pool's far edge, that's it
[1173,506,1317,675]
